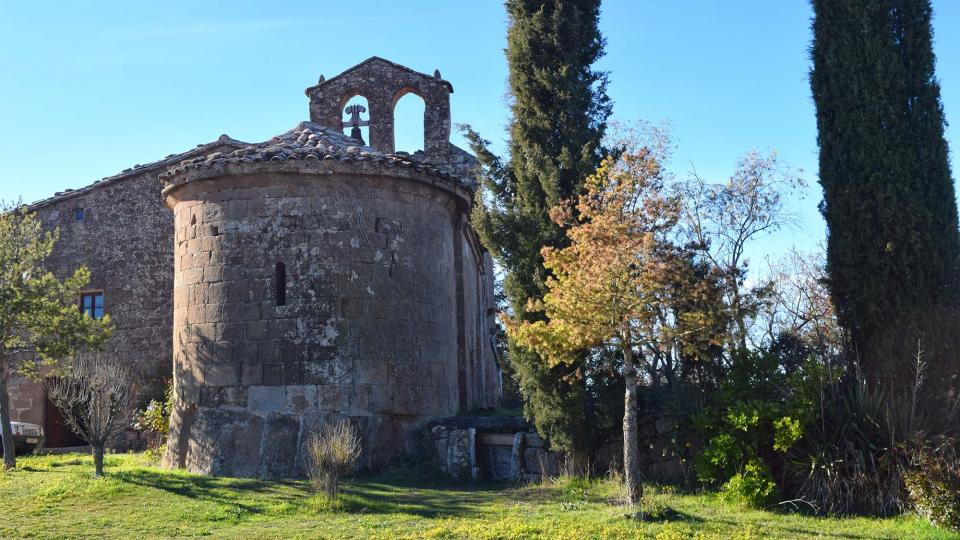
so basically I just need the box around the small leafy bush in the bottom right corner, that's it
[904,449,960,531]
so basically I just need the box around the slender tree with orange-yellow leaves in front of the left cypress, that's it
[505,149,709,504]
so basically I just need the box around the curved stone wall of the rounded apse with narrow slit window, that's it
[161,173,490,477]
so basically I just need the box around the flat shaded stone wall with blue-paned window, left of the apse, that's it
[10,140,240,436]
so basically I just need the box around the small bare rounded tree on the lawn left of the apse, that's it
[44,352,133,477]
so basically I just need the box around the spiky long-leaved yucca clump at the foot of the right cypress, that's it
[789,348,957,515]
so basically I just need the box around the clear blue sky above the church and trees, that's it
[0,0,960,264]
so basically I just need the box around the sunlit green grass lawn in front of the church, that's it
[0,454,958,539]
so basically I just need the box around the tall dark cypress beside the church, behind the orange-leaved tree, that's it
[469,0,611,450]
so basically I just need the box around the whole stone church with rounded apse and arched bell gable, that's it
[12,57,500,478]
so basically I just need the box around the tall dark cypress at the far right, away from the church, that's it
[810,0,960,383]
